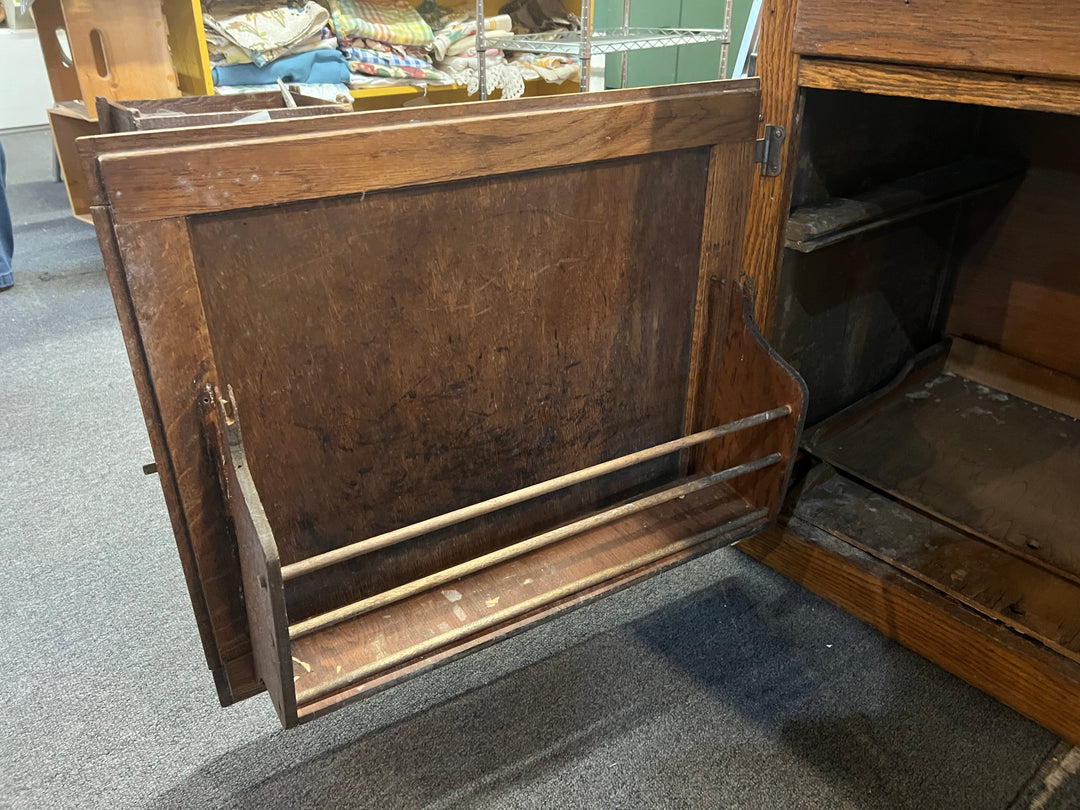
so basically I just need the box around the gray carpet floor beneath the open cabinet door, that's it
[0,133,1080,810]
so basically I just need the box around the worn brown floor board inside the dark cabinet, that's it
[805,364,1080,581]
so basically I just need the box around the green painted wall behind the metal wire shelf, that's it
[596,0,751,87]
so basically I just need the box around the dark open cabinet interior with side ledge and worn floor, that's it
[773,91,1080,673]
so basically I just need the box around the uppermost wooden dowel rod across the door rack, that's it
[274,405,792,582]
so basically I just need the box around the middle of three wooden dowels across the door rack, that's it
[288,453,781,640]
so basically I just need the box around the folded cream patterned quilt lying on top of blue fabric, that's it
[203,0,329,67]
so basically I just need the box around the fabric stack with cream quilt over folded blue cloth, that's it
[203,0,349,85]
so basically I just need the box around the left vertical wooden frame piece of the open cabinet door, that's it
[113,219,259,697]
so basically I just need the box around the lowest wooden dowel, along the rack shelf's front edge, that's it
[296,509,768,705]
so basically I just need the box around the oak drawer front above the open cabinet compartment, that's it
[794,0,1080,79]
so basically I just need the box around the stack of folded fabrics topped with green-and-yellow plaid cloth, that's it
[330,0,454,87]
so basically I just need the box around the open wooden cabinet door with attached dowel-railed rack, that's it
[81,80,804,726]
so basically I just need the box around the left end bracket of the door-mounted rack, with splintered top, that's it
[203,397,297,728]
